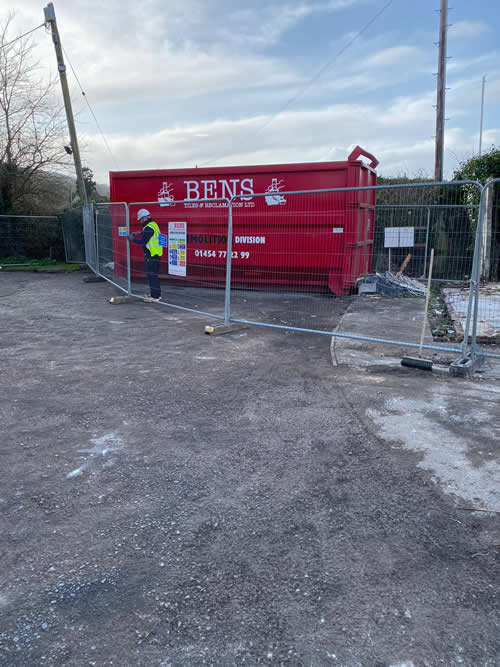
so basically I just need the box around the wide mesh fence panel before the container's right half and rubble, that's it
[228,182,481,352]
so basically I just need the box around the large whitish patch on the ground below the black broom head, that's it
[367,396,500,508]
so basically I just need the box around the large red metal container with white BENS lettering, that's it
[110,146,378,295]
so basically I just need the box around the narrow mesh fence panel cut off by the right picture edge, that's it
[472,178,500,359]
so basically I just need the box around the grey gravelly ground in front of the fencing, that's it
[0,273,500,667]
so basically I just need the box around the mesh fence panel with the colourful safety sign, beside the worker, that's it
[130,199,229,318]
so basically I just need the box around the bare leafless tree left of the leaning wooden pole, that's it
[0,14,68,213]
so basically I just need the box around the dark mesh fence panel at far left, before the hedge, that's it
[0,215,65,266]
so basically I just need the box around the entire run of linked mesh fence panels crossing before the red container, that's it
[89,181,492,356]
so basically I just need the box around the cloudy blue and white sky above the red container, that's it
[4,0,500,182]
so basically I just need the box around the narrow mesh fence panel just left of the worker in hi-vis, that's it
[94,203,129,292]
